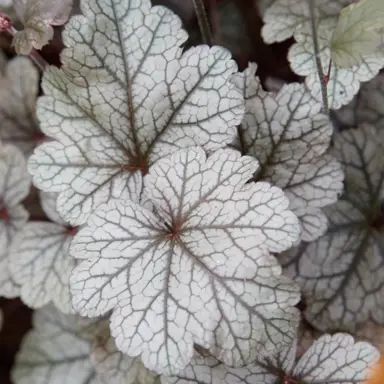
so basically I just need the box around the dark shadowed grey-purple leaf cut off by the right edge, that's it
[281,125,384,332]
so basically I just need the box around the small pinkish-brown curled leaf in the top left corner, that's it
[12,0,72,55]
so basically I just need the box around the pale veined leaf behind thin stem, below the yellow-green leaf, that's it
[288,18,384,109]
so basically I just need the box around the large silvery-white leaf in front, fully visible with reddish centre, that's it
[71,148,300,374]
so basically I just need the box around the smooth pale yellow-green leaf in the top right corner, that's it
[331,0,384,68]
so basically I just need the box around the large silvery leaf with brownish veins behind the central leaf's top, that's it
[29,0,244,225]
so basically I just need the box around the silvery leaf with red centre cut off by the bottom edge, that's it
[162,333,380,384]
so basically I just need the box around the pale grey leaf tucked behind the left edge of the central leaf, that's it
[9,193,76,313]
